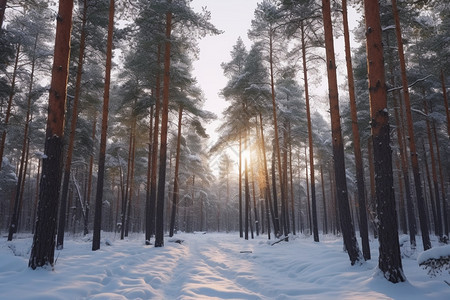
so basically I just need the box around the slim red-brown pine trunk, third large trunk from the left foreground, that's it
[92,0,114,251]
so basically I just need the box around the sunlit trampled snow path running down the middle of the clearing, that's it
[165,234,266,299]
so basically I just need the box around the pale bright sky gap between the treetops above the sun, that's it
[192,0,259,140]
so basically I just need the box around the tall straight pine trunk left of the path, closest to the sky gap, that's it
[155,4,172,247]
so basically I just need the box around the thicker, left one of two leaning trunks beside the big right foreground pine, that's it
[322,0,361,265]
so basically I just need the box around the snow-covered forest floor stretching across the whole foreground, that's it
[0,233,450,300]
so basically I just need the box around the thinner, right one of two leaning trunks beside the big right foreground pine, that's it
[342,0,370,260]
